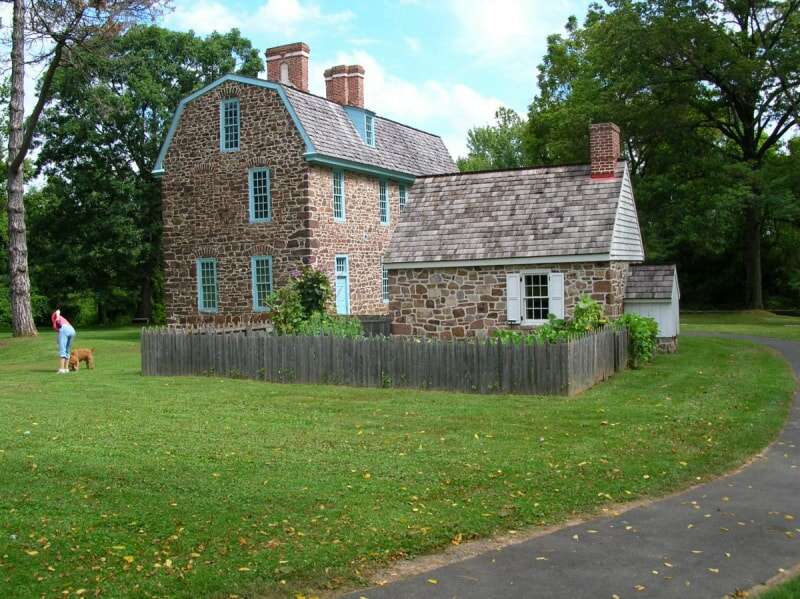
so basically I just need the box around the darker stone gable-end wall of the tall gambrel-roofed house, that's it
[162,82,311,323]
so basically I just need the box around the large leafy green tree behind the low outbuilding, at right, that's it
[524,0,800,307]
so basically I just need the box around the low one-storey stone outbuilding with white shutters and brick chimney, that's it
[385,123,644,339]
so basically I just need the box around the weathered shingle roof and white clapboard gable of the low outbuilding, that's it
[384,162,644,268]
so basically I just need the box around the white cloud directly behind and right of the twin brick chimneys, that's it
[309,51,503,158]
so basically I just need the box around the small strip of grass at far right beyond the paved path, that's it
[681,310,800,341]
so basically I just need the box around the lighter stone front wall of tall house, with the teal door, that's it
[309,167,400,314]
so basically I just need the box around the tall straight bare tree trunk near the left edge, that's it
[7,0,37,337]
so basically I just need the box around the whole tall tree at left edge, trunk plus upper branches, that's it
[6,0,167,336]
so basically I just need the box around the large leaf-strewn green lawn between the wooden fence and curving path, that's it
[0,329,795,599]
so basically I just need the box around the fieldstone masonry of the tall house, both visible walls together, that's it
[162,82,399,324]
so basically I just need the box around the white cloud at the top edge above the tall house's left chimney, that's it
[166,0,353,37]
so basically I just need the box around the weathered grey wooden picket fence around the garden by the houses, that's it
[141,328,628,395]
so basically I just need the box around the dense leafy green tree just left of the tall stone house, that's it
[32,25,263,322]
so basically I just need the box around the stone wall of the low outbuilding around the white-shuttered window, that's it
[389,262,628,339]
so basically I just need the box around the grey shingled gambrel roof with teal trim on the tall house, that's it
[153,75,456,182]
